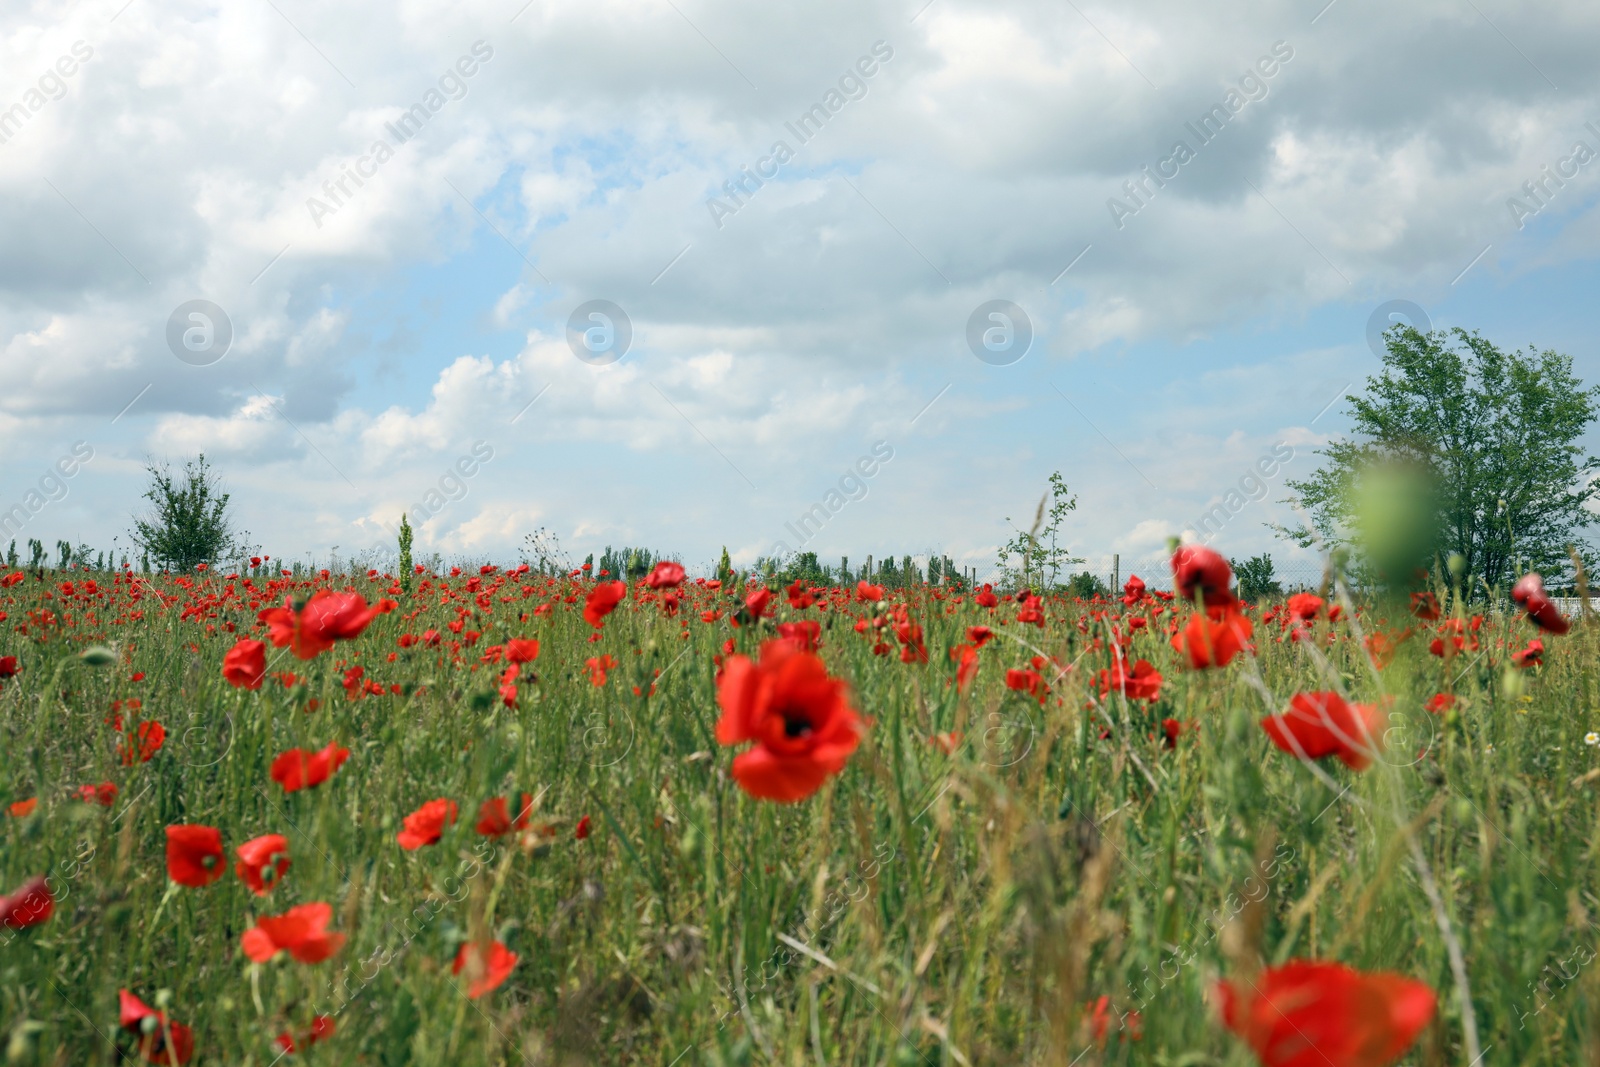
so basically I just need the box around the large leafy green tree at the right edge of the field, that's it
[1278,326,1600,589]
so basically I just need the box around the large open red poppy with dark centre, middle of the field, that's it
[717,640,862,803]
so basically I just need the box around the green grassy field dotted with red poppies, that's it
[0,549,1600,1067]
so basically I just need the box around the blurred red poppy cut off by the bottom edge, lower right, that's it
[1216,960,1438,1067]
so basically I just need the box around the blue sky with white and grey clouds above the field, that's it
[0,0,1600,573]
